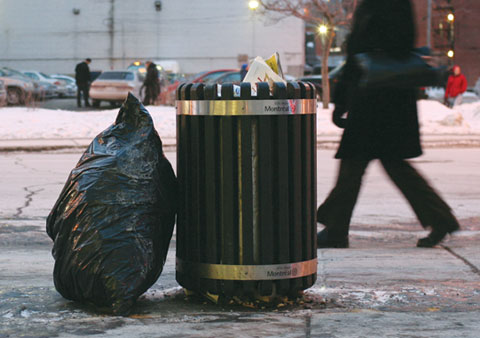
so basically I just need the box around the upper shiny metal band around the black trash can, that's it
[177,99,317,116]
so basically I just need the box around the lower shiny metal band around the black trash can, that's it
[176,257,317,281]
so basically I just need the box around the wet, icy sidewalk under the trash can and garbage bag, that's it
[0,223,480,338]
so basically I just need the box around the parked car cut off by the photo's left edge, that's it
[0,67,35,105]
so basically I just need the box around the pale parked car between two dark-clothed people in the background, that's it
[90,70,143,107]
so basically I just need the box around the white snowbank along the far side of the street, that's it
[0,100,480,140]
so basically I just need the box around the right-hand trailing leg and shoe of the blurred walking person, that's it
[381,159,460,247]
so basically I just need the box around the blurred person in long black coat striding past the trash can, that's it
[317,0,459,248]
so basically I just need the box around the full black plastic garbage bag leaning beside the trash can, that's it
[47,94,177,315]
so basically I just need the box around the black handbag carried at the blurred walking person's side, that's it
[354,51,446,89]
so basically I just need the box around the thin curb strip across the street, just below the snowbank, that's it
[0,134,480,152]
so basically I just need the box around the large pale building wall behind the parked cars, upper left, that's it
[0,0,304,75]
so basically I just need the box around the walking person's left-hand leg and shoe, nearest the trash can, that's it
[317,159,369,247]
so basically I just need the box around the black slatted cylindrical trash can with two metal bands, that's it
[176,82,317,296]
